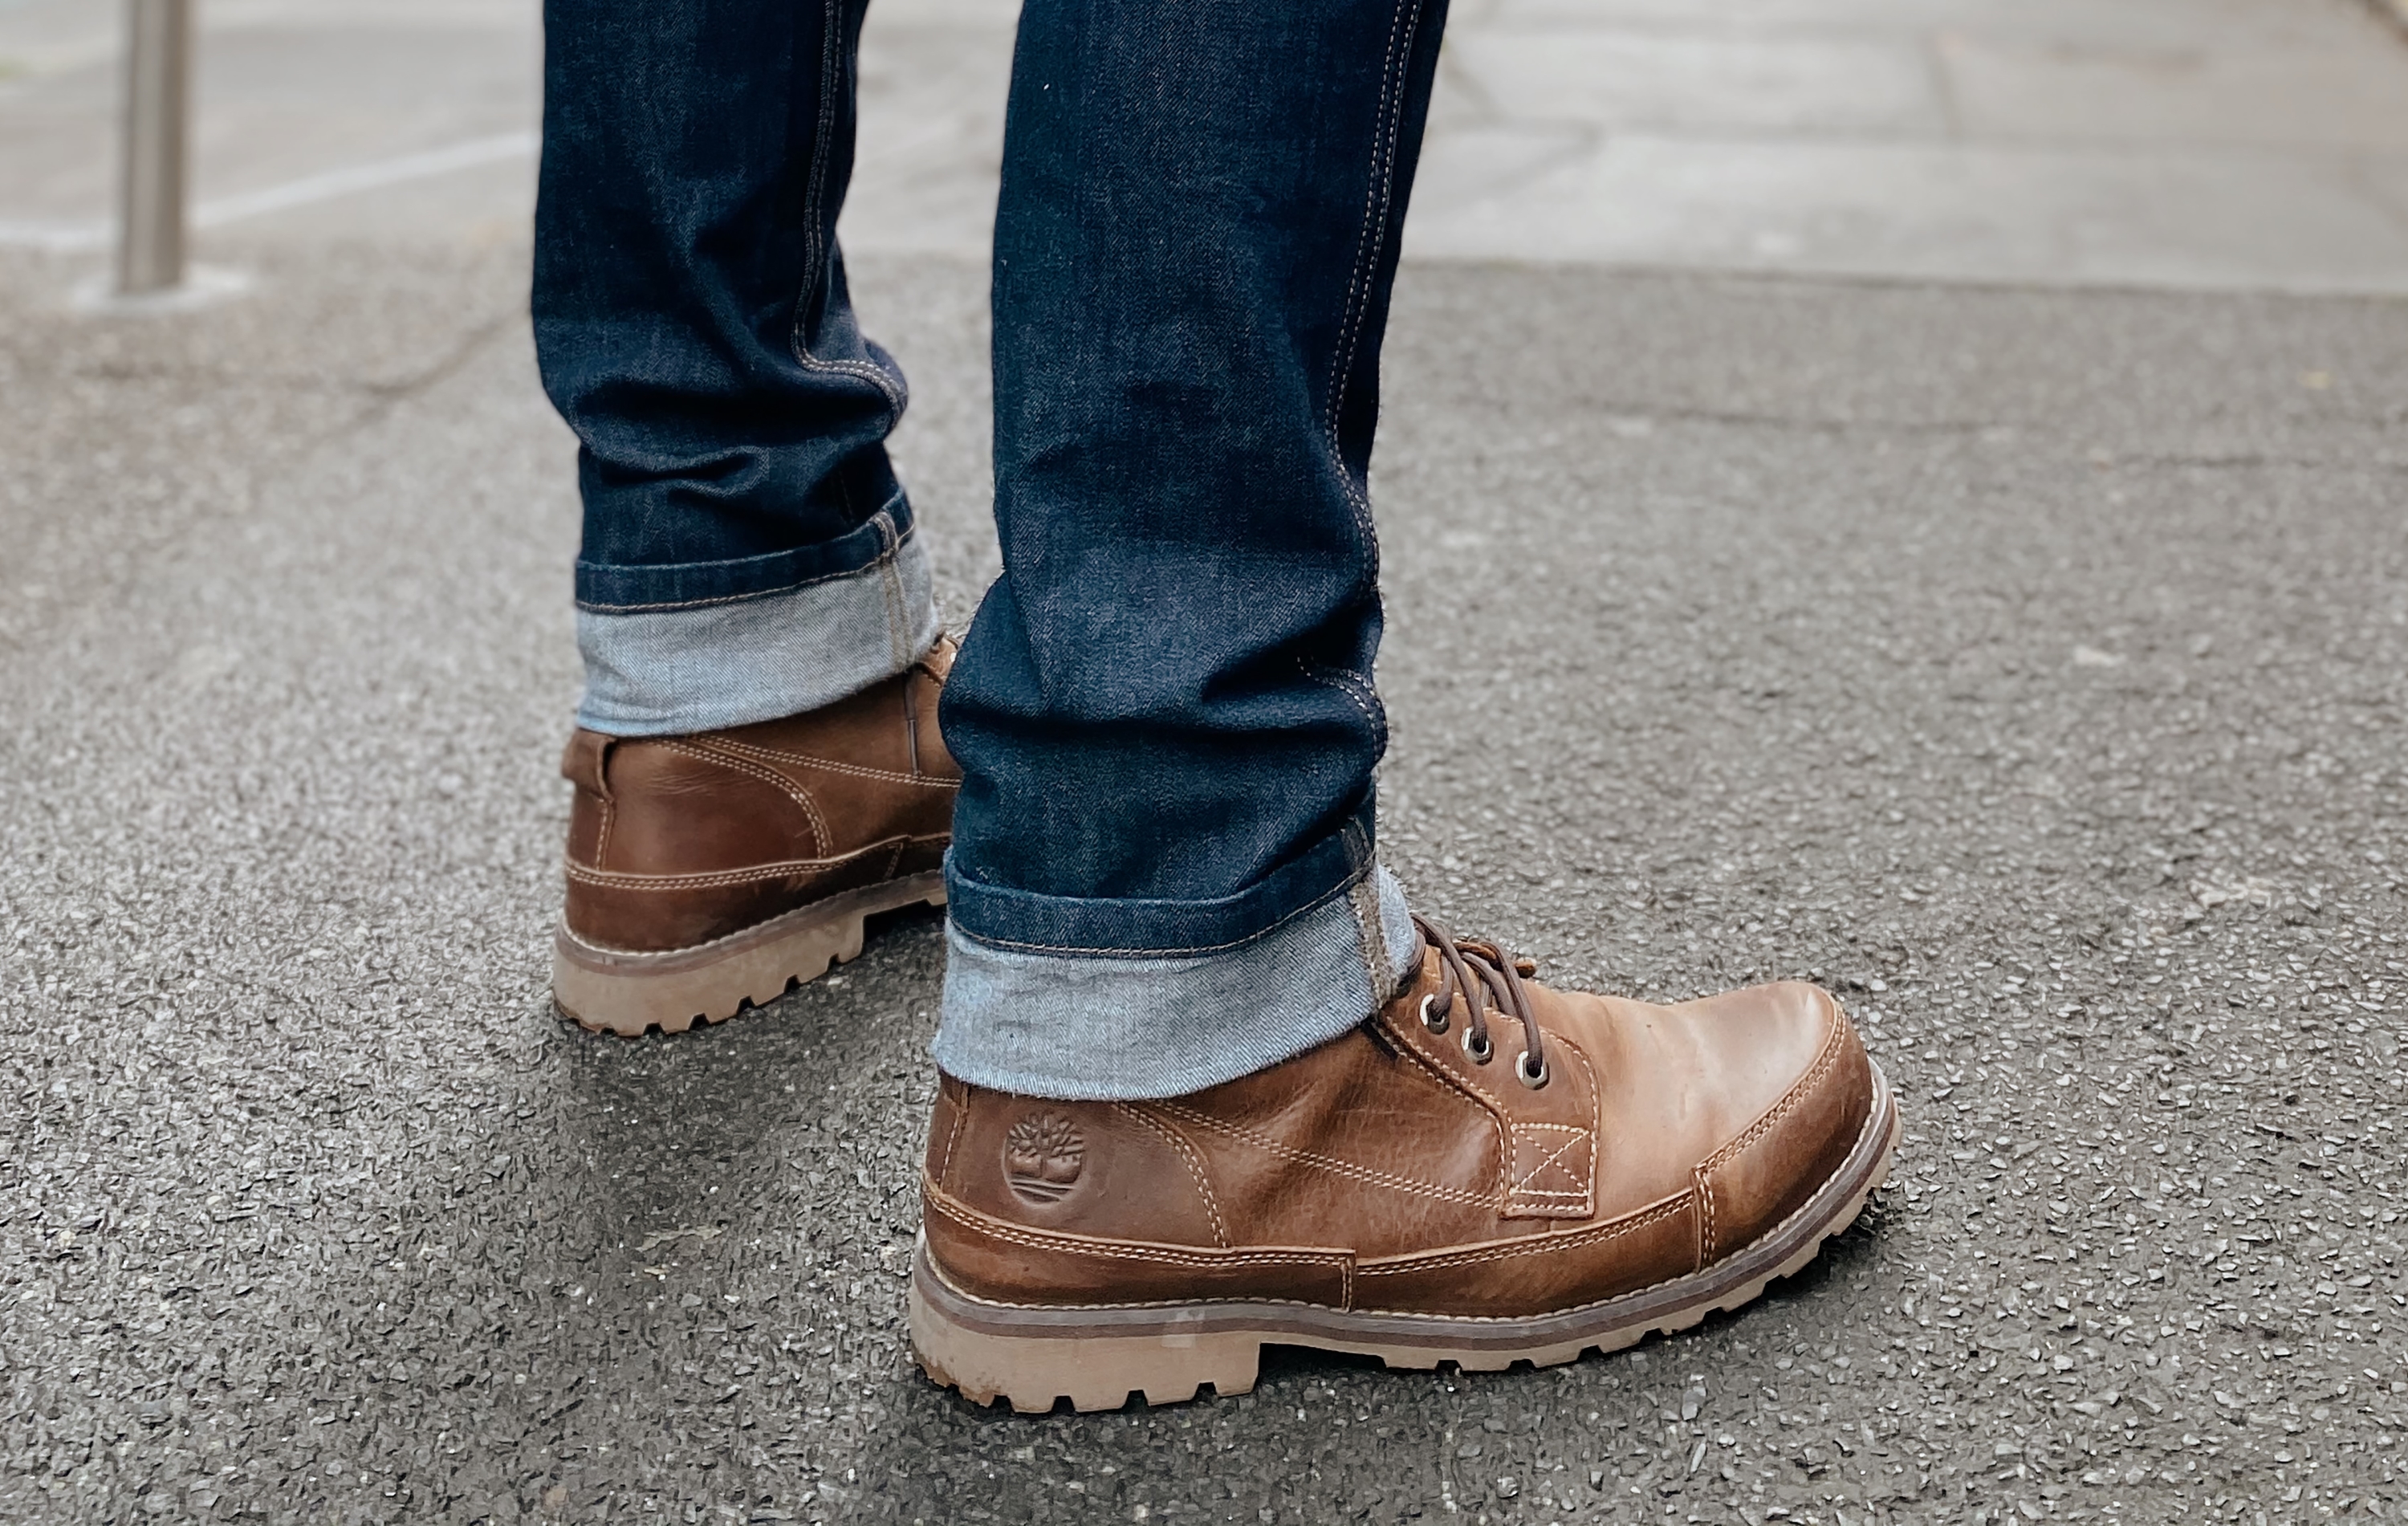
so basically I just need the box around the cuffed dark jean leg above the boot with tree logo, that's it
[937,0,1442,1097]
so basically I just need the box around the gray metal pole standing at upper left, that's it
[118,0,193,296]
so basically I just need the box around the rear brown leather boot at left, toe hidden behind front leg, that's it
[551,641,961,1037]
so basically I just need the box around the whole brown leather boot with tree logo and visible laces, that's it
[910,924,1898,1410]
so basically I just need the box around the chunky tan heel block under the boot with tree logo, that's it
[910,1251,1262,1415]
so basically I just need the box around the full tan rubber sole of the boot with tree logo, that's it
[910,1066,1900,1415]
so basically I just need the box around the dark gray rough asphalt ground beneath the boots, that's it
[0,246,2408,1524]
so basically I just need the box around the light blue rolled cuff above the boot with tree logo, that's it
[934,864,1421,1102]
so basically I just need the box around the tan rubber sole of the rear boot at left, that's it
[551,869,944,1037]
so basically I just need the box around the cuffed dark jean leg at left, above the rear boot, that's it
[532,0,937,737]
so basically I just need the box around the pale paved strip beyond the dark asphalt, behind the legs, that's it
[0,0,2408,283]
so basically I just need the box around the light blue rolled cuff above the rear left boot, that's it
[578,515,939,737]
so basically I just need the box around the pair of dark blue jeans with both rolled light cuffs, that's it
[535,0,1442,1097]
